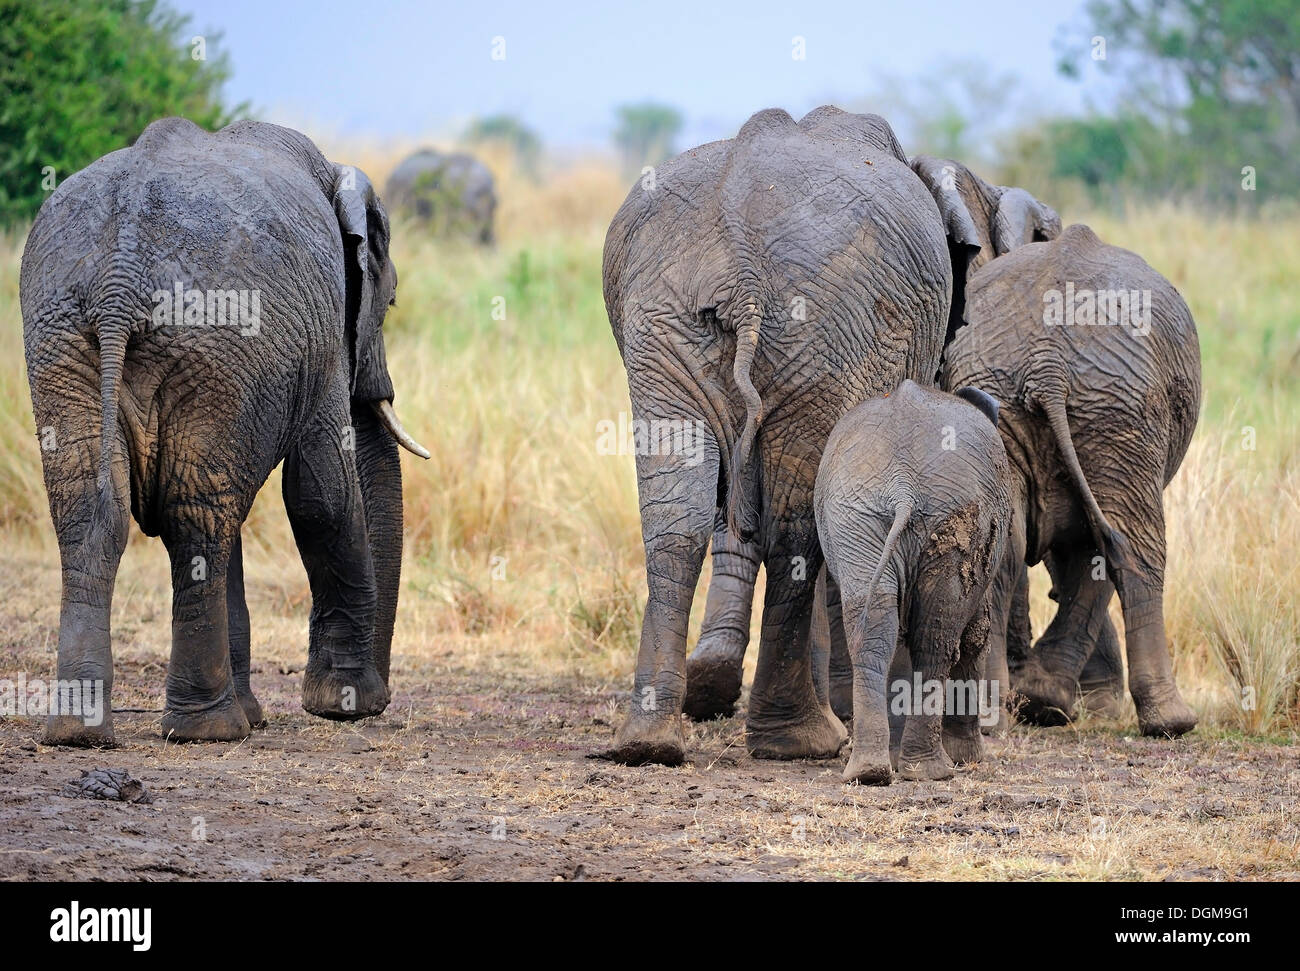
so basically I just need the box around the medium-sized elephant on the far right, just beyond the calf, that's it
[941,225,1201,736]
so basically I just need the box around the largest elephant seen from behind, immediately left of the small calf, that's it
[605,108,952,764]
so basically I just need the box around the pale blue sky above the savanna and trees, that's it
[173,0,1107,148]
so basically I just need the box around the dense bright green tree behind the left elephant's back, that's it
[0,0,247,225]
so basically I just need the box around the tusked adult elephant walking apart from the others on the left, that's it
[21,118,419,745]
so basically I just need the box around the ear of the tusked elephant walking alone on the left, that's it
[334,165,393,402]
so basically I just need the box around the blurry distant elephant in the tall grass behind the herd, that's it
[384,148,497,246]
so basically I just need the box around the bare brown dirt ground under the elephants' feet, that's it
[0,545,1300,880]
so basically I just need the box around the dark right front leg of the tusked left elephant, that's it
[282,403,389,720]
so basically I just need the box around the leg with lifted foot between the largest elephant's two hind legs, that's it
[683,515,759,721]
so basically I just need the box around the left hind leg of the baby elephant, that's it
[842,577,900,785]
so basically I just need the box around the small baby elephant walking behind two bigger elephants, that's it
[815,381,1011,785]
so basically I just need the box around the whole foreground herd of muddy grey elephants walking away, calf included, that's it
[21,107,1200,784]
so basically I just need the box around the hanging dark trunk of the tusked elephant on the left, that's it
[352,403,402,684]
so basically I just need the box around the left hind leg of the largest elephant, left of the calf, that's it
[599,434,718,766]
